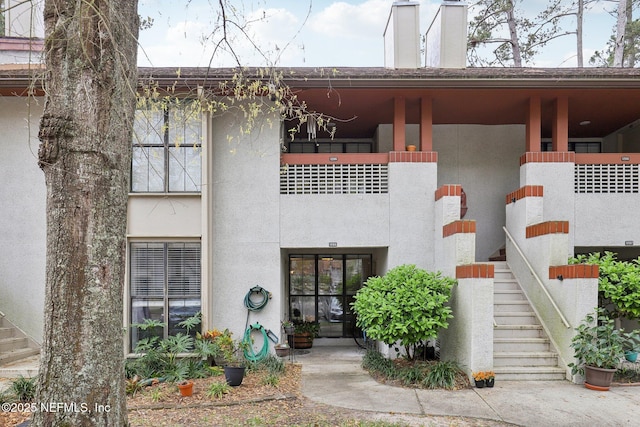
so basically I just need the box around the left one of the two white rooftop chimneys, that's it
[384,0,420,68]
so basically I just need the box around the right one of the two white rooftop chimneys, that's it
[425,0,467,68]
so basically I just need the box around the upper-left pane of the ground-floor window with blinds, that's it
[130,243,165,297]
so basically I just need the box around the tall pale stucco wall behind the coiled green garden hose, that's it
[209,112,284,346]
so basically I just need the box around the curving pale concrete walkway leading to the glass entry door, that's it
[296,344,640,427]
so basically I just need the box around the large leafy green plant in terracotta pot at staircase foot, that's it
[568,308,628,391]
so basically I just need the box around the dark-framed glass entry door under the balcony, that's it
[289,254,372,337]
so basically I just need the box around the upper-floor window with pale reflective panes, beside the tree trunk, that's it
[131,102,202,193]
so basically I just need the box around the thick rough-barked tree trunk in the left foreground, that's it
[32,0,139,427]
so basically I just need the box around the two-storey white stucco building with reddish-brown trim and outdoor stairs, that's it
[0,2,640,378]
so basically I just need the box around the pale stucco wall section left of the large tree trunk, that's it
[0,96,46,342]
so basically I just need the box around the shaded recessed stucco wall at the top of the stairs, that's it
[433,125,525,261]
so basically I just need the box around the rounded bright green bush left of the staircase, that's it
[352,265,456,360]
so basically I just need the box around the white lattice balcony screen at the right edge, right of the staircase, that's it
[575,164,639,193]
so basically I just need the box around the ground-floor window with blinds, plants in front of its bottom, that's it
[129,242,201,349]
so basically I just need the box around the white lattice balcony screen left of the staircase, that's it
[280,165,389,194]
